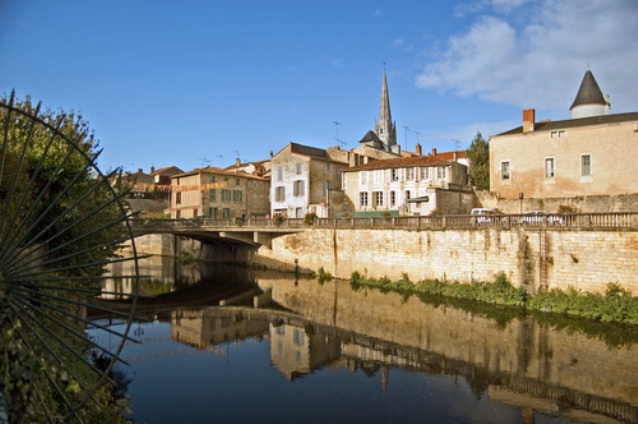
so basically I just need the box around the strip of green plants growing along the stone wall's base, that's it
[350,272,638,332]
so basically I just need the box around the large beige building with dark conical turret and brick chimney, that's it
[490,71,638,200]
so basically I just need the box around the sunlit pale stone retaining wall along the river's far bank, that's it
[251,228,638,295]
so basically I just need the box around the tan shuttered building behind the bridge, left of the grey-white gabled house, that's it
[170,167,270,219]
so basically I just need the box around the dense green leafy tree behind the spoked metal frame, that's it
[0,95,130,422]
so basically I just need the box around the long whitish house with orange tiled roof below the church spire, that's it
[343,148,474,215]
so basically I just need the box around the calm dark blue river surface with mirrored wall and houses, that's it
[91,256,638,424]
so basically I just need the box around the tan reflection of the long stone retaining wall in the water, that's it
[272,280,638,407]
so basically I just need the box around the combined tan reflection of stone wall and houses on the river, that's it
[111,258,638,423]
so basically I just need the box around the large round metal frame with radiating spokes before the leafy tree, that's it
[0,93,140,422]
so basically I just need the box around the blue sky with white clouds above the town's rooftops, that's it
[0,0,638,172]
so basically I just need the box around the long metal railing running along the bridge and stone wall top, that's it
[133,212,638,232]
